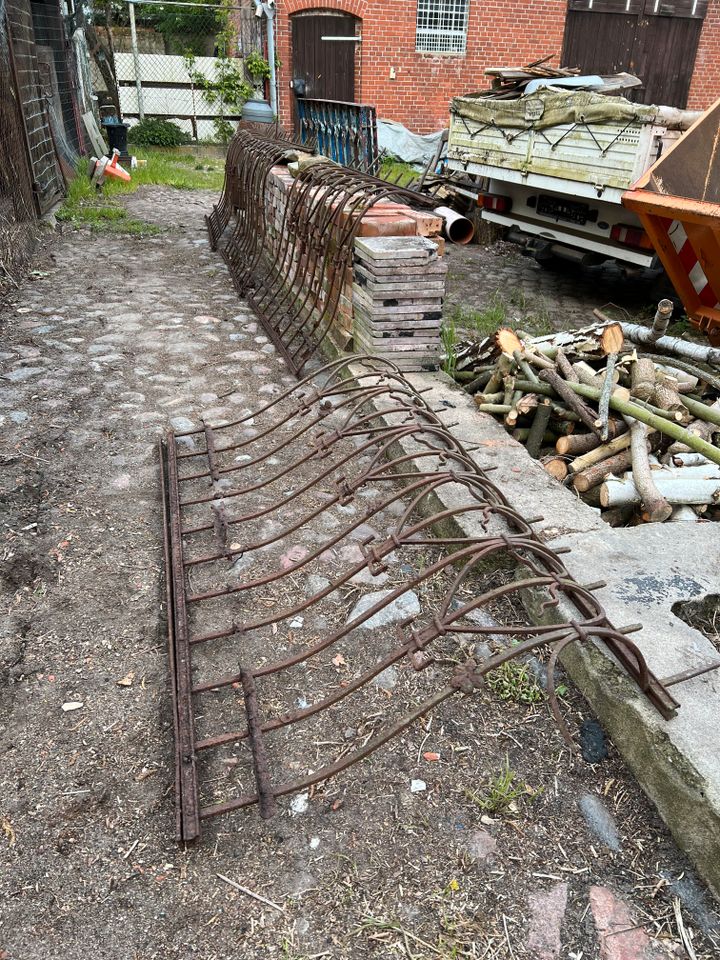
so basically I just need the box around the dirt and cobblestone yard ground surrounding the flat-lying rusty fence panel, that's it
[0,188,720,960]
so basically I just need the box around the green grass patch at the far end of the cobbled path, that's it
[56,147,225,236]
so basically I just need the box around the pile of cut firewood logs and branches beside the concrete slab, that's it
[455,300,720,526]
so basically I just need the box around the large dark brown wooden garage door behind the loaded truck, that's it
[562,0,707,107]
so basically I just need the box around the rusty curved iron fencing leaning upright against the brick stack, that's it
[207,130,436,376]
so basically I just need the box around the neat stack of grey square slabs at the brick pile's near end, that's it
[353,236,447,370]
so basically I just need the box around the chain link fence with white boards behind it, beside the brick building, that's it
[94,0,269,141]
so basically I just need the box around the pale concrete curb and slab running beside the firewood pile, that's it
[346,367,720,898]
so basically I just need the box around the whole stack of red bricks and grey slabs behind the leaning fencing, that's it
[258,166,447,370]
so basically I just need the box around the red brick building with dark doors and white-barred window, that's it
[276,0,720,133]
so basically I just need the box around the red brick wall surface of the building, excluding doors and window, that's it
[277,0,720,133]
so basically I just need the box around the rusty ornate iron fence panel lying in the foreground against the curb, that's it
[161,357,677,841]
